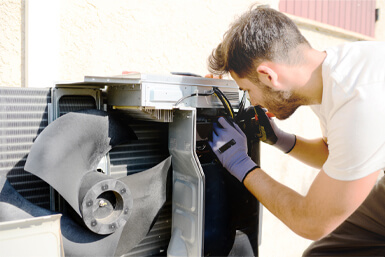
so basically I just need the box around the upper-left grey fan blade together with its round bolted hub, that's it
[24,110,137,234]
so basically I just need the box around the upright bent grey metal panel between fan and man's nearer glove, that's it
[168,109,205,256]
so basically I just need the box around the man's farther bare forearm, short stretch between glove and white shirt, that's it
[289,136,329,169]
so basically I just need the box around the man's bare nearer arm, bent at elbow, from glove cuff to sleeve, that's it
[243,168,380,240]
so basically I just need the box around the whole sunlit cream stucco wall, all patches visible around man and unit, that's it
[0,0,385,257]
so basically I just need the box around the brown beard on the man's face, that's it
[263,87,306,120]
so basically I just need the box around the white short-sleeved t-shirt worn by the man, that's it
[312,42,385,180]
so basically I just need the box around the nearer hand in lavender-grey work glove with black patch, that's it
[209,117,259,183]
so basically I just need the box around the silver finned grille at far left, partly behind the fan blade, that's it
[0,88,51,209]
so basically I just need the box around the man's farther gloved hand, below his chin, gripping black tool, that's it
[254,106,296,153]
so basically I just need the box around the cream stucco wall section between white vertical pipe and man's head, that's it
[59,0,260,80]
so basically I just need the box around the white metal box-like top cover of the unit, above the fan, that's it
[84,73,239,110]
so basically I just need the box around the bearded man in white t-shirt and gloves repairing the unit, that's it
[208,7,385,256]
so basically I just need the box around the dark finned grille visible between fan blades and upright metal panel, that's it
[110,121,171,256]
